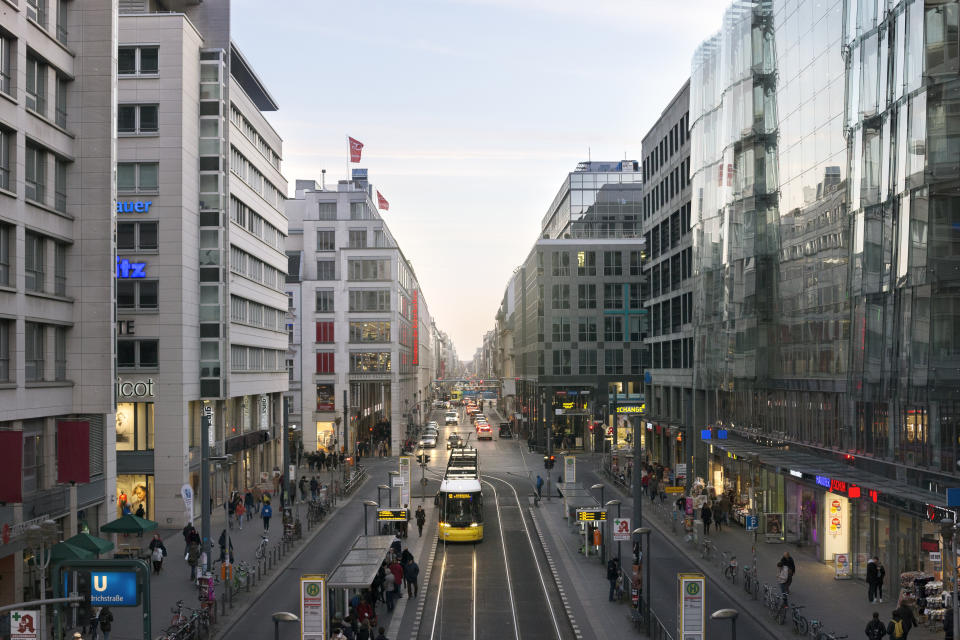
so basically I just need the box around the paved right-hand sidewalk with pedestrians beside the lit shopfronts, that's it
[592,462,943,640]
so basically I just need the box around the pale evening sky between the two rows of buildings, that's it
[232,0,729,360]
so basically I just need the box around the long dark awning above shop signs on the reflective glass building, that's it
[704,440,946,518]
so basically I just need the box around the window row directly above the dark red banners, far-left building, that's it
[0,318,69,383]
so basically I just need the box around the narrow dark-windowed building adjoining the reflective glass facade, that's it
[642,81,694,467]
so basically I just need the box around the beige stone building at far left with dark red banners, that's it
[0,0,116,604]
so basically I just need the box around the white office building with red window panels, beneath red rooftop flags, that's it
[287,170,436,455]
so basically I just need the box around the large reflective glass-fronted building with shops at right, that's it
[690,0,960,576]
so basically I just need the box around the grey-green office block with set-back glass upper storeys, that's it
[513,161,647,451]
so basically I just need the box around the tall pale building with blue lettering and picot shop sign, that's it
[114,0,288,526]
